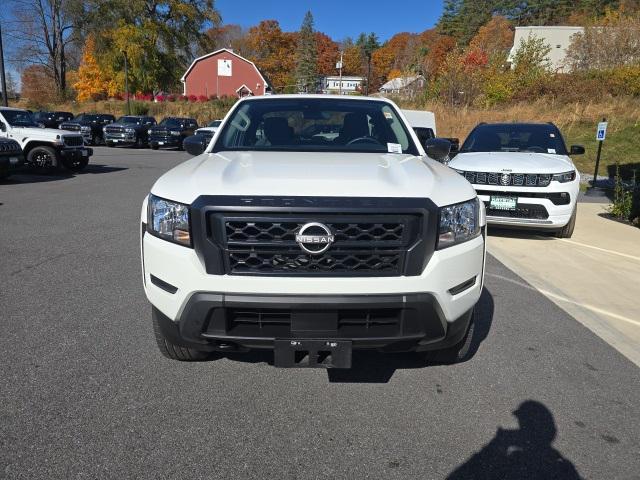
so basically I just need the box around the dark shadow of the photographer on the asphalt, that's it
[447,400,582,480]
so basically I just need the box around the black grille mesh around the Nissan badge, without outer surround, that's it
[213,214,420,276]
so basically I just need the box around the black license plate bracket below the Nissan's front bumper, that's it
[273,340,351,368]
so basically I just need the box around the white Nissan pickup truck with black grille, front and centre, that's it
[141,95,485,368]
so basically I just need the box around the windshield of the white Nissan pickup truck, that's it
[214,97,418,155]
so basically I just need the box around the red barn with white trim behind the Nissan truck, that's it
[180,48,270,97]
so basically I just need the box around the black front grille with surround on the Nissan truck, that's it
[191,197,438,277]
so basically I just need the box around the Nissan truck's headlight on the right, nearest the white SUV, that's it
[437,198,480,249]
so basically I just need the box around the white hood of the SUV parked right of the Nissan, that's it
[449,152,576,173]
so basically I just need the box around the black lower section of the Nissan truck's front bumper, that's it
[153,293,472,351]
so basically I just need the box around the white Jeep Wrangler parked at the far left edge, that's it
[0,107,93,172]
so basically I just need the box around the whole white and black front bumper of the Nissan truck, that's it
[141,229,485,350]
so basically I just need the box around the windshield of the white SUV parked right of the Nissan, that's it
[460,123,567,155]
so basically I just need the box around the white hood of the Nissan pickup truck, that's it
[151,152,476,206]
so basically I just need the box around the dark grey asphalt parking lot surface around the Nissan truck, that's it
[0,147,640,479]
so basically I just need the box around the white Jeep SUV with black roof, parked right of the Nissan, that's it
[448,123,584,238]
